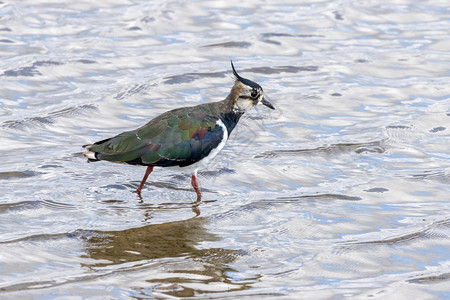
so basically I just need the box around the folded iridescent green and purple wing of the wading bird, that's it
[89,105,224,166]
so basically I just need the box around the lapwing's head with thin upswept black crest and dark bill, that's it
[229,61,275,112]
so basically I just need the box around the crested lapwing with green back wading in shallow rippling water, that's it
[82,61,275,201]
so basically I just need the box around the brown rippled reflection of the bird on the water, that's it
[79,217,253,296]
